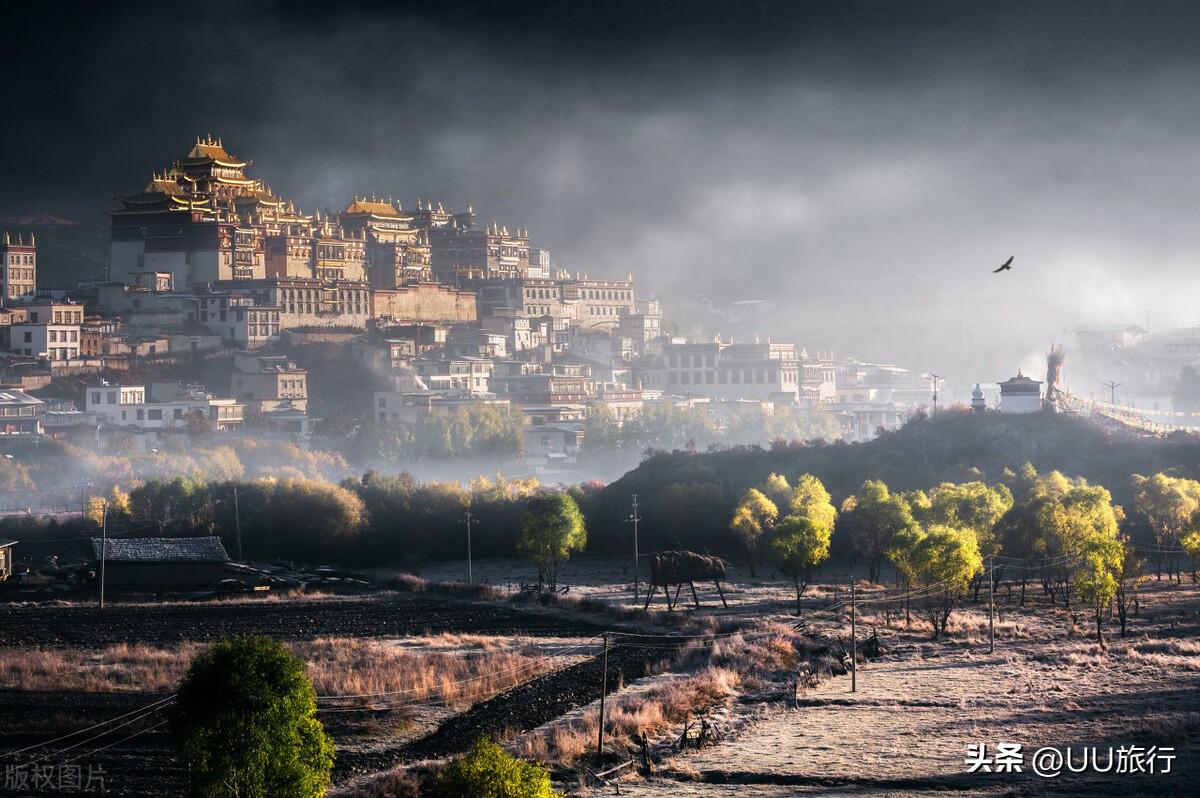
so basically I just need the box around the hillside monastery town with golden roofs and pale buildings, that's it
[0,137,1113,472]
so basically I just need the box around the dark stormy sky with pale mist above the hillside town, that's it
[0,0,1200,383]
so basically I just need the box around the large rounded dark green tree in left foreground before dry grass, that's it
[172,636,334,798]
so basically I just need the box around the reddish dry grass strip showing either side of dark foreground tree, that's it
[0,635,566,703]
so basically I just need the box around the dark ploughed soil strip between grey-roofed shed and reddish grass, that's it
[0,594,599,648]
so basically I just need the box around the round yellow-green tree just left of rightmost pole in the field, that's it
[905,524,983,640]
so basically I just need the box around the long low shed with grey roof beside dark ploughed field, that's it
[91,536,229,590]
